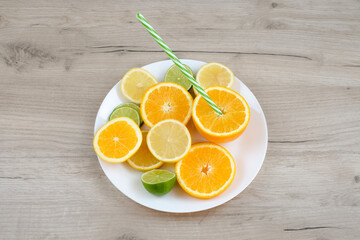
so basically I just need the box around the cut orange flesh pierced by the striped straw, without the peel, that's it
[196,90,246,133]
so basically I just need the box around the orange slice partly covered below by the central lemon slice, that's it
[140,82,193,128]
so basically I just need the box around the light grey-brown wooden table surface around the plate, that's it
[0,0,360,240]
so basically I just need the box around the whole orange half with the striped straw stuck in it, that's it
[192,86,250,143]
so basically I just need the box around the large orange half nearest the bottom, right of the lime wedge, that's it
[175,143,236,198]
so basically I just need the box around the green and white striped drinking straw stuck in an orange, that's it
[136,13,222,115]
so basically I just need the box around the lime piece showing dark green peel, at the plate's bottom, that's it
[141,169,176,196]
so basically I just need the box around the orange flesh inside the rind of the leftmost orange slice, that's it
[98,121,138,158]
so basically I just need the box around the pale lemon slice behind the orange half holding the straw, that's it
[194,63,235,95]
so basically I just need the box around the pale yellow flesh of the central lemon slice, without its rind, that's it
[148,122,189,159]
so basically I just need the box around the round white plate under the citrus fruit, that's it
[94,59,268,213]
